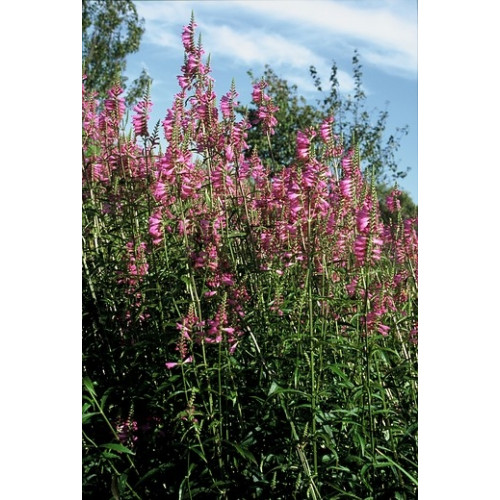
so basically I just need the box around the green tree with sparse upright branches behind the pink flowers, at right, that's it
[240,51,414,198]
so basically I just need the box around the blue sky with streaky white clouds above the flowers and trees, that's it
[127,0,418,201]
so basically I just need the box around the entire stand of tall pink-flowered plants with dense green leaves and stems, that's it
[82,13,418,500]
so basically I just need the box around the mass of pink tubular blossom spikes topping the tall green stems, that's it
[82,14,418,369]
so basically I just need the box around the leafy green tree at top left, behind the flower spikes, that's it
[82,0,151,104]
